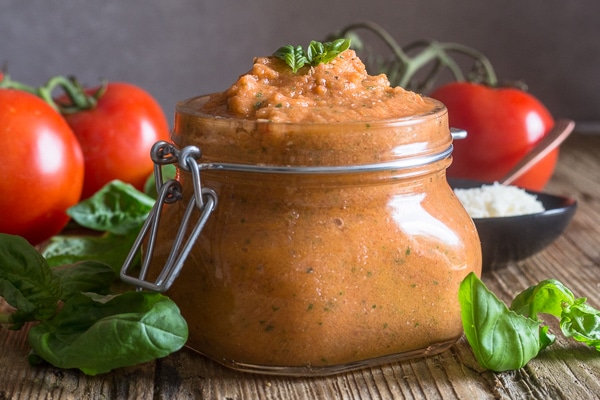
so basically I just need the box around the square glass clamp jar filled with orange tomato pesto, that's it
[124,97,481,375]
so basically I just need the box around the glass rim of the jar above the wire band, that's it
[171,95,452,169]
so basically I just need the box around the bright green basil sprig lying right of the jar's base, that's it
[459,273,600,372]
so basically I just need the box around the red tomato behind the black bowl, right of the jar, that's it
[431,82,558,191]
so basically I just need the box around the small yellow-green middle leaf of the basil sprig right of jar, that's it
[510,279,575,320]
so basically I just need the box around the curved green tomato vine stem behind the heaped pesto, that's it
[336,21,498,92]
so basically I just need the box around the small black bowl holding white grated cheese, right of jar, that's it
[448,178,577,272]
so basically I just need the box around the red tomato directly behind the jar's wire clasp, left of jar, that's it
[61,82,169,198]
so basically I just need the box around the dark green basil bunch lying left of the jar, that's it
[0,181,188,375]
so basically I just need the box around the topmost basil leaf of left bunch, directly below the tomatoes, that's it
[67,180,154,235]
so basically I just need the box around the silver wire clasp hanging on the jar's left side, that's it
[121,141,217,292]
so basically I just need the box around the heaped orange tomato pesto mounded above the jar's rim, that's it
[205,50,432,123]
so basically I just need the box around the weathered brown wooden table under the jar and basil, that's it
[0,134,600,400]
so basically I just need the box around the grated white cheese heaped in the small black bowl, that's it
[454,182,544,218]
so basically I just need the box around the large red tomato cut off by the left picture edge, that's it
[0,89,83,244]
